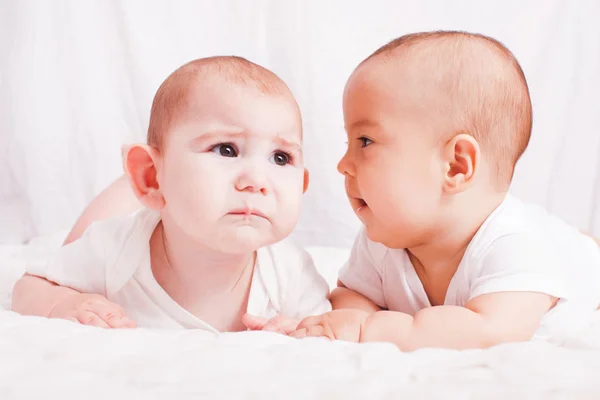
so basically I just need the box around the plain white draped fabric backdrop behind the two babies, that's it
[0,0,600,246]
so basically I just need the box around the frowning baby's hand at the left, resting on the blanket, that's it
[48,293,135,328]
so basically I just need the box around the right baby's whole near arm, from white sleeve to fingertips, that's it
[292,235,568,350]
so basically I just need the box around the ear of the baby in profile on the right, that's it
[444,133,480,193]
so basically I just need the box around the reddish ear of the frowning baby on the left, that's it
[122,144,165,210]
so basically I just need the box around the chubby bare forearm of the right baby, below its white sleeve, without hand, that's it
[359,292,557,350]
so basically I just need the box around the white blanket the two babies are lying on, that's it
[0,241,600,399]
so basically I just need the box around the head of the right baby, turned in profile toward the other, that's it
[338,32,532,248]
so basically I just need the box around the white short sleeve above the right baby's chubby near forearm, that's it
[469,233,569,300]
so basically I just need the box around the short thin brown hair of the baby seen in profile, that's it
[362,31,532,187]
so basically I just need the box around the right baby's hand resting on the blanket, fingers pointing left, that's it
[290,309,370,342]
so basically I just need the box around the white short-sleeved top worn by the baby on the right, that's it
[340,195,600,339]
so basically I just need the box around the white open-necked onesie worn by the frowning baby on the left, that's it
[27,209,331,332]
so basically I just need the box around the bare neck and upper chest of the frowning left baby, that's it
[150,220,255,330]
